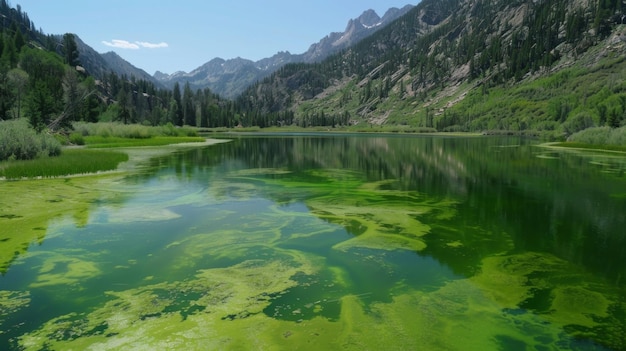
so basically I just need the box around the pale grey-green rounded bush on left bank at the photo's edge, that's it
[0,119,61,161]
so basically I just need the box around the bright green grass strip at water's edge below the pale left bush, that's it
[0,149,128,179]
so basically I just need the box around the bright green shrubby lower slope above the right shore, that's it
[438,59,626,138]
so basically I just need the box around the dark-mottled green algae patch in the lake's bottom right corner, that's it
[470,252,626,349]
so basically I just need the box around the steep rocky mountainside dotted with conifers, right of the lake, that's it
[237,0,626,135]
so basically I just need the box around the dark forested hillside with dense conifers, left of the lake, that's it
[0,0,235,136]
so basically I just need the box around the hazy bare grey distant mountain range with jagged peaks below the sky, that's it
[154,5,413,98]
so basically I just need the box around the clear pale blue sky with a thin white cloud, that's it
[9,0,419,74]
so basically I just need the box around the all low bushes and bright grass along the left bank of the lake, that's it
[0,119,206,179]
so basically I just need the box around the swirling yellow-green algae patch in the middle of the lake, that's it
[218,169,456,251]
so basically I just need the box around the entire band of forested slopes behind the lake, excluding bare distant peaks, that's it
[0,0,626,146]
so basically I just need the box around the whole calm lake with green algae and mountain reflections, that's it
[0,135,626,350]
